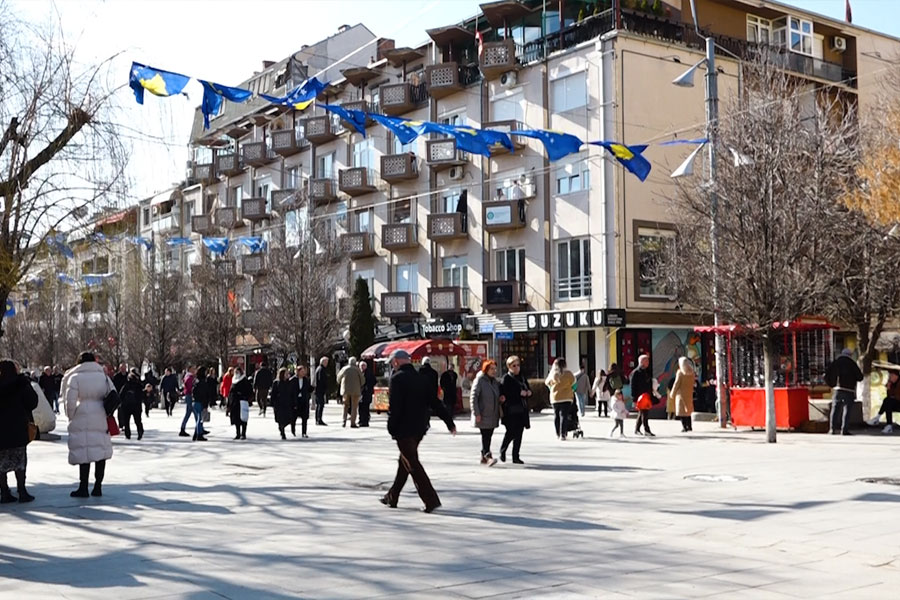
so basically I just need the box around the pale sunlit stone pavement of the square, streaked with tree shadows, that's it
[0,404,900,600]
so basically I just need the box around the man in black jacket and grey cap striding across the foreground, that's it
[381,350,456,513]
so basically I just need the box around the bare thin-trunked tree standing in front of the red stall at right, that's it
[671,55,857,442]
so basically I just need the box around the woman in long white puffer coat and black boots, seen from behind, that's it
[60,352,113,498]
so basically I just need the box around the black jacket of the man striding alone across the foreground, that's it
[388,363,456,440]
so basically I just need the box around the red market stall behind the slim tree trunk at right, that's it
[695,317,835,429]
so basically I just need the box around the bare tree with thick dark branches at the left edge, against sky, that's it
[0,0,125,335]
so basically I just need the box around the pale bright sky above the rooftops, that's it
[13,0,900,199]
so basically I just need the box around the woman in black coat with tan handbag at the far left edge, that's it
[0,360,38,504]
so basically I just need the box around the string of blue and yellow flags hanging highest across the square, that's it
[129,62,707,181]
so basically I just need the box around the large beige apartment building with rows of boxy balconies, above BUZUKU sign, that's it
[174,0,900,378]
